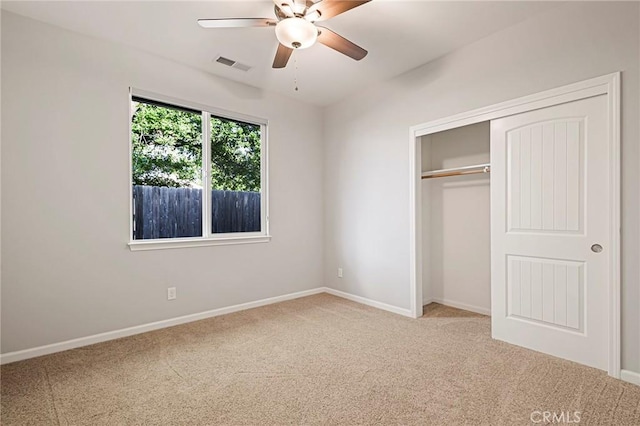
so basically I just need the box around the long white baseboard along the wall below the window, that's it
[0,287,325,365]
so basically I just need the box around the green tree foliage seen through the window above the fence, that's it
[131,102,260,191]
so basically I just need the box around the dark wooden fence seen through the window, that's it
[133,185,260,240]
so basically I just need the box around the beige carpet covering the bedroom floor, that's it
[0,294,640,426]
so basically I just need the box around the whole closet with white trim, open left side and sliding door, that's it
[409,73,621,377]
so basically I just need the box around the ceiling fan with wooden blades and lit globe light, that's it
[198,0,371,68]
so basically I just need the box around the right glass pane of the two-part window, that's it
[211,117,261,234]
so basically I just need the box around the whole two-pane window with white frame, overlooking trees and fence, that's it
[129,91,269,250]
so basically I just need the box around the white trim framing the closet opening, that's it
[409,72,620,378]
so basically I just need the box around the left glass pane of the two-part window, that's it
[131,98,202,240]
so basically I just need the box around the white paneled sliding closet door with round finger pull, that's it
[491,96,612,370]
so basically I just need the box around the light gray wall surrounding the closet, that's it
[324,2,640,372]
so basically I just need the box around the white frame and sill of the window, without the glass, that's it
[128,88,271,251]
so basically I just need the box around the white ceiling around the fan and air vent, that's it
[2,0,553,105]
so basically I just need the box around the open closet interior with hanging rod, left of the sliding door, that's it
[418,121,491,316]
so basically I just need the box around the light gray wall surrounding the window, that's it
[1,12,323,353]
